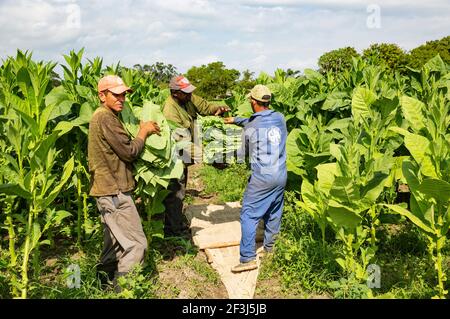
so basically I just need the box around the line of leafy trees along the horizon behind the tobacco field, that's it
[112,36,450,100]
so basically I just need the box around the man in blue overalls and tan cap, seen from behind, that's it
[225,84,287,272]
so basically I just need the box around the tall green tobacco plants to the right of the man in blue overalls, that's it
[241,56,450,298]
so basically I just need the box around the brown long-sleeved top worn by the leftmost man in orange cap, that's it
[88,106,144,196]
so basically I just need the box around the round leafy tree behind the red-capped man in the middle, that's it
[186,61,240,100]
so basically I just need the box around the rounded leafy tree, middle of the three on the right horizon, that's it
[363,43,408,71]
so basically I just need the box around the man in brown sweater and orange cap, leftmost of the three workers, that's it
[88,75,160,290]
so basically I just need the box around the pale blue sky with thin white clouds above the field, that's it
[0,0,450,73]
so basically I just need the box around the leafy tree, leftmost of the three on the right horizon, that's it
[319,47,359,73]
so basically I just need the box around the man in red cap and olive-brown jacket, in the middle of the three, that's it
[163,75,230,236]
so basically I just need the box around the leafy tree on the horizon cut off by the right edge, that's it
[409,36,450,69]
